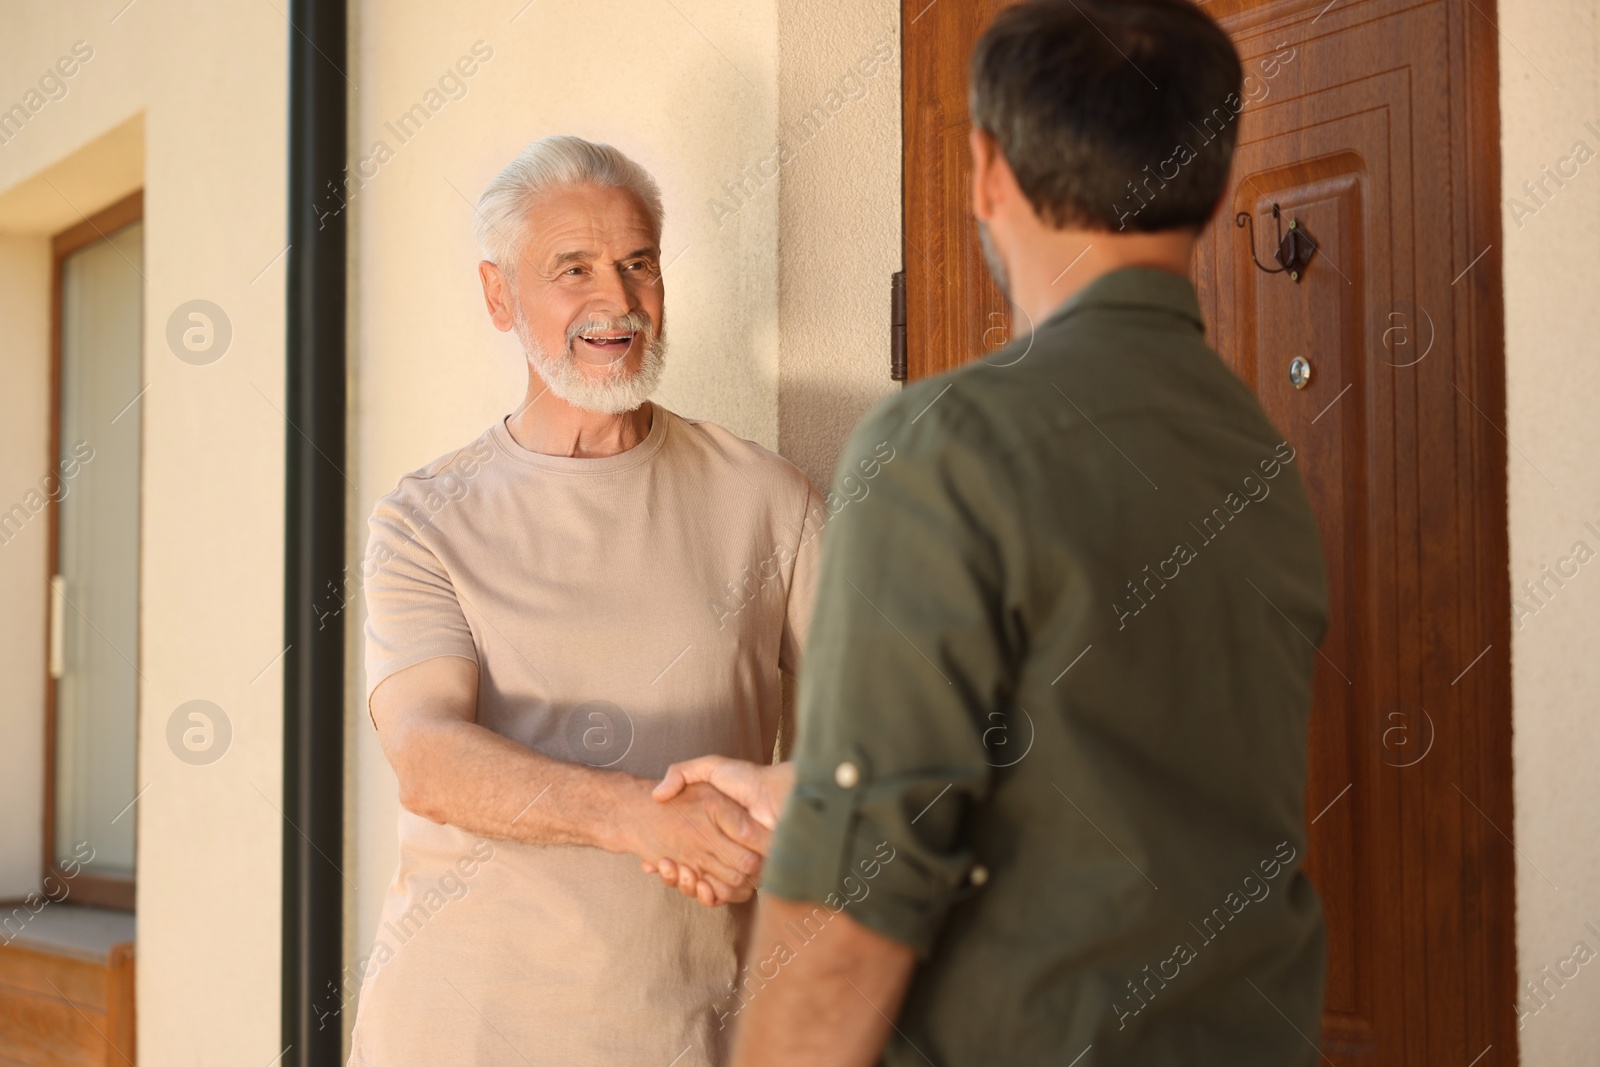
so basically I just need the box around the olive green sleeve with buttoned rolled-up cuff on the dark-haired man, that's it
[763,390,1016,955]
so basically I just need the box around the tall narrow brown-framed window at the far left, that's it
[45,194,144,909]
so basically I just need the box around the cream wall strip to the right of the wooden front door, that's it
[1499,0,1600,1067]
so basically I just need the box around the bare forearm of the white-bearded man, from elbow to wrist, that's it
[392,721,653,853]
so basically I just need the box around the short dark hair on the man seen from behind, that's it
[971,0,1243,232]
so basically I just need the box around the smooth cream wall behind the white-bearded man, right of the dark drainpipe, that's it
[346,0,779,1025]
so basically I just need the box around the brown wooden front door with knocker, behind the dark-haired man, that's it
[902,0,1517,1067]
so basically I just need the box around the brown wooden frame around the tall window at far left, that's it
[40,189,144,912]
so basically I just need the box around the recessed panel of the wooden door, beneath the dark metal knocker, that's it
[1224,152,1386,1048]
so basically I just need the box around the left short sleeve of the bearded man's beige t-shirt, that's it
[362,494,478,701]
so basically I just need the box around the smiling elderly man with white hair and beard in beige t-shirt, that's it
[350,138,826,1067]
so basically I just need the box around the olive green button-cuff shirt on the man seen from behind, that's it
[758,269,1326,1067]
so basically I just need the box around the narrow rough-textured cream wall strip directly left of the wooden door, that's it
[778,0,901,490]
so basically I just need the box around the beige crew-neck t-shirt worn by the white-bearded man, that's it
[350,405,827,1067]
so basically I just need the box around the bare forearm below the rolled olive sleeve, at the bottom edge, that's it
[733,893,917,1067]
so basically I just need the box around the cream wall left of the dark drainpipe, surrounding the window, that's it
[0,0,290,1067]
